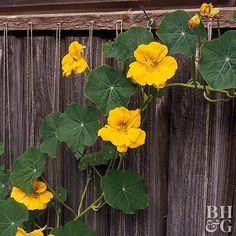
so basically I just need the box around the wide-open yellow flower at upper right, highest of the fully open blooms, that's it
[127,42,178,88]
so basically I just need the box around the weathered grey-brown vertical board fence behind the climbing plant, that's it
[0,31,236,236]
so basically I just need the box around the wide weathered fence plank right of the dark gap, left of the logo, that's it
[167,57,209,236]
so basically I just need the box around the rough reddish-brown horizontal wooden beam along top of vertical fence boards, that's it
[0,7,236,30]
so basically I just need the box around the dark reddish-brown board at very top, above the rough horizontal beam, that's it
[0,0,232,15]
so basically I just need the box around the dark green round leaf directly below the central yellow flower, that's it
[101,170,148,214]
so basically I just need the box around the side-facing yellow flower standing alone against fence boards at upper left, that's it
[62,41,88,77]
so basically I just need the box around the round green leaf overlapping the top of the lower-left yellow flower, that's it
[11,148,45,194]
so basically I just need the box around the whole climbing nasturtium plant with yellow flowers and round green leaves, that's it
[0,3,236,236]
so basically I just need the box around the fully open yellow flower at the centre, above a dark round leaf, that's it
[98,107,146,152]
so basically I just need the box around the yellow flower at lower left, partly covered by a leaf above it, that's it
[11,180,53,210]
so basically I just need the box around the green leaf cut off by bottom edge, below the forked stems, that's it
[51,220,96,236]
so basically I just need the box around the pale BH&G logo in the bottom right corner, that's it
[206,206,232,233]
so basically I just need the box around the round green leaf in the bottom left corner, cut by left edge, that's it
[0,198,28,236]
